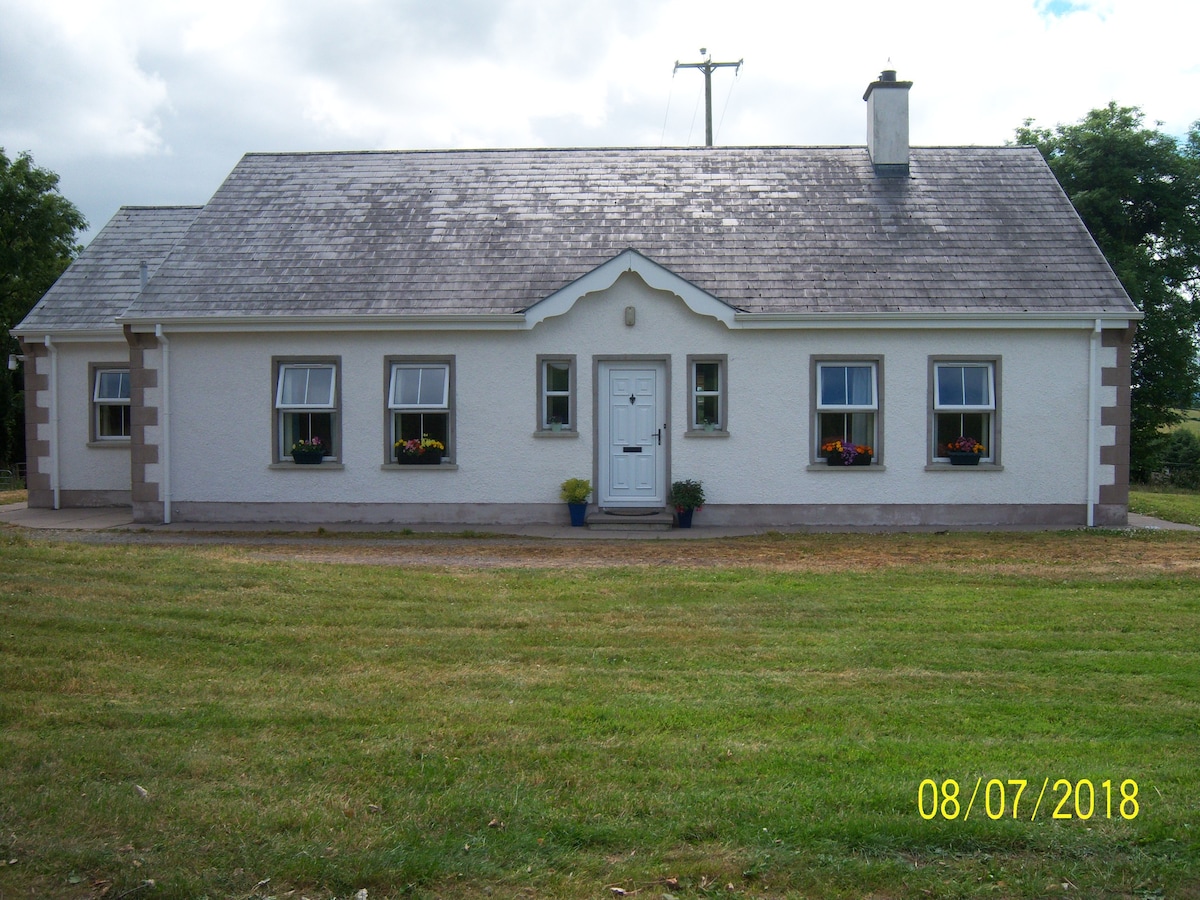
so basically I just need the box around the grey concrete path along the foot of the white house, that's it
[0,503,1200,540]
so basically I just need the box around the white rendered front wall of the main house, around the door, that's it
[150,276,1120,526]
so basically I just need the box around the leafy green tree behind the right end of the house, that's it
[1016,103,1200,479]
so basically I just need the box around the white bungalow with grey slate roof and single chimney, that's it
[16,72,1140,527]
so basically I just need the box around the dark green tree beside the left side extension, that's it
[0,148,88,463]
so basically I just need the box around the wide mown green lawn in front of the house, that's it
[0,529,1200,900]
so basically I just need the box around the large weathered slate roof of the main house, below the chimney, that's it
[54,148,1135,320]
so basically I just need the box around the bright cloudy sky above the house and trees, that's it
[0,0,1200,240]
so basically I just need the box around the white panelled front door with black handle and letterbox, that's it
[598,362,667,508]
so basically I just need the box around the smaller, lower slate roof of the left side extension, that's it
[13,206,200,332]
